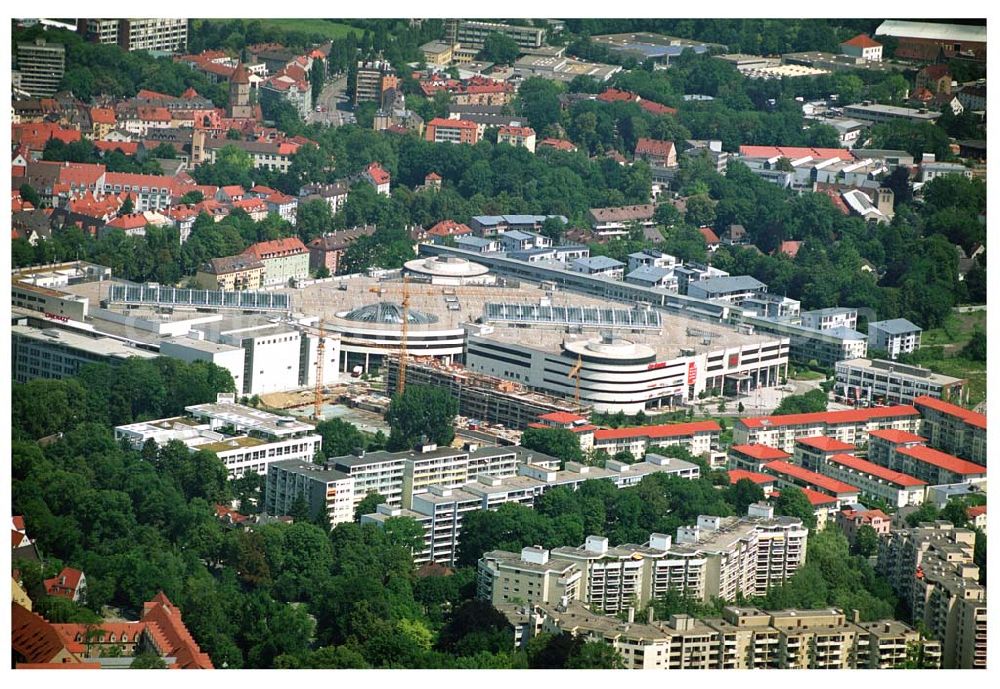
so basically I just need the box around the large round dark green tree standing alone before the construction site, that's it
[385,385,458,451]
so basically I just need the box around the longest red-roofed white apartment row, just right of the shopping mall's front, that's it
[733,405,920,453]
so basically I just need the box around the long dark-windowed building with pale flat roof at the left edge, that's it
[11,324,157,383]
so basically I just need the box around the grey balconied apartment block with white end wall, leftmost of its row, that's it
[264,460,354,527]
